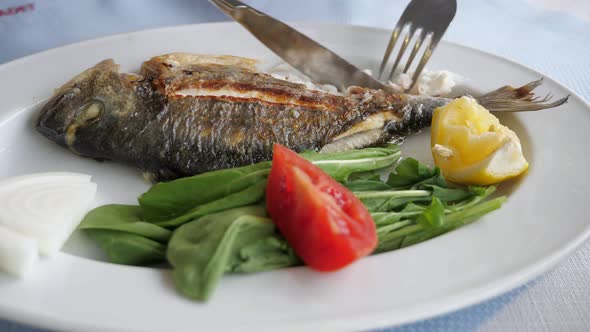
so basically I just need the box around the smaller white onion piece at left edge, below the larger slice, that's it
[0,226,38,277]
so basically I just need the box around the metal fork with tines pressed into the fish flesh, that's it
[379,0,457,90]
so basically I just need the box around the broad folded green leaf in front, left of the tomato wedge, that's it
[167,206,300,300]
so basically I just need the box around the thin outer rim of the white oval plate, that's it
[0,21,590,331]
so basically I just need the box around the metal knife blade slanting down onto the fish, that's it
[209,0,387,91]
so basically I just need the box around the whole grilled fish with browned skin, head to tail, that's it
[36,53,566,181]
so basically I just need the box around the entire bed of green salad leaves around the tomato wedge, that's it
[79,145,505,300]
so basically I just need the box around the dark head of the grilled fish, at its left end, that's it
[36,59,135,147]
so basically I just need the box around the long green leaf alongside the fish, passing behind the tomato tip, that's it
[139,145,401,223]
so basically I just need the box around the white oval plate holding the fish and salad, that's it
[0,23,590,331]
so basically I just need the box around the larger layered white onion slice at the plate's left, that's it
[0,173,96,255]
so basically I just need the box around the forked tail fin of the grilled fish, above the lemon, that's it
[476,78,569,112]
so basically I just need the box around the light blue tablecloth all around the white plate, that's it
[0,0,590,332]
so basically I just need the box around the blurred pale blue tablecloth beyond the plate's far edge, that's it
[0,0,590,95]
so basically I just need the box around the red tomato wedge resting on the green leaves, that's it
[266,144,377,271]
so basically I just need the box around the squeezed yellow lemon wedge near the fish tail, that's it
[431,97,529,185]
